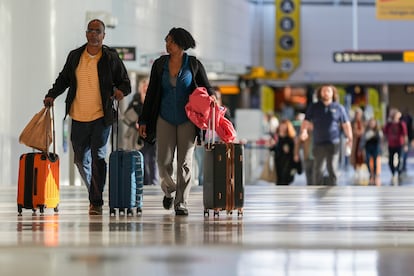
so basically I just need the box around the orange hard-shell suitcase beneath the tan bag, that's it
[17,152,59,214]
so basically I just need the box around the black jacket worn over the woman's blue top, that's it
[139,55,215,143]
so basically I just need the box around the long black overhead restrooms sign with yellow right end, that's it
[333,51,414,63]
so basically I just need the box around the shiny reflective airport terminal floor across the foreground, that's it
[0,158,414,276]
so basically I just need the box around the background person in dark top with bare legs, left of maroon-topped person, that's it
[361,118,383,186]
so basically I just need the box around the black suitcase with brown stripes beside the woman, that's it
[203,143,244,216]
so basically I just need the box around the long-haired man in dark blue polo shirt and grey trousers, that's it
[300,85,352,185]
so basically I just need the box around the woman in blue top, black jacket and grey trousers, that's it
[139,28,214,215]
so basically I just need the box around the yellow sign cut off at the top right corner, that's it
[375,0,414,20]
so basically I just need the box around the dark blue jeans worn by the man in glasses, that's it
[71,118,111,206]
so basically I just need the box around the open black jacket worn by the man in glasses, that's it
[46,44,131,125]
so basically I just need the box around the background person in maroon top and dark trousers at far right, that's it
[384,109,408,185]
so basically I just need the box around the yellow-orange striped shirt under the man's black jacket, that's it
[69,49,104,122]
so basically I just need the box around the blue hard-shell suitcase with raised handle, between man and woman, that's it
[109,102,144,216]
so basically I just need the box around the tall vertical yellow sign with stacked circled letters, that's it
[275,0,300,75]
